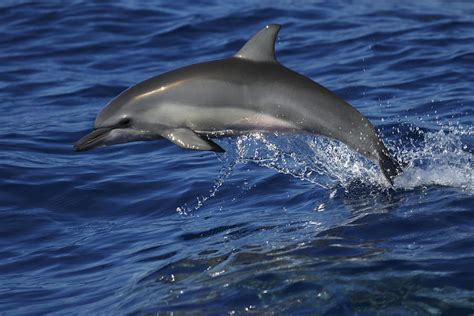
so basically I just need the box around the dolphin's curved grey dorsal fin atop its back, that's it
[234,24,280,62]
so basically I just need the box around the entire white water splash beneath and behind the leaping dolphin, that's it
[177,126,474,214]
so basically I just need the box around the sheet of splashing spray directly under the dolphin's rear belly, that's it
[236,133,386,189]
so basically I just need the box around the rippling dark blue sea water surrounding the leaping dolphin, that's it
[0,0,474,315]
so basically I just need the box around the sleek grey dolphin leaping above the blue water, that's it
[74,24,401,185]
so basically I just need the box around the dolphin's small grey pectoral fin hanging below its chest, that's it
[162,128,225,153]
